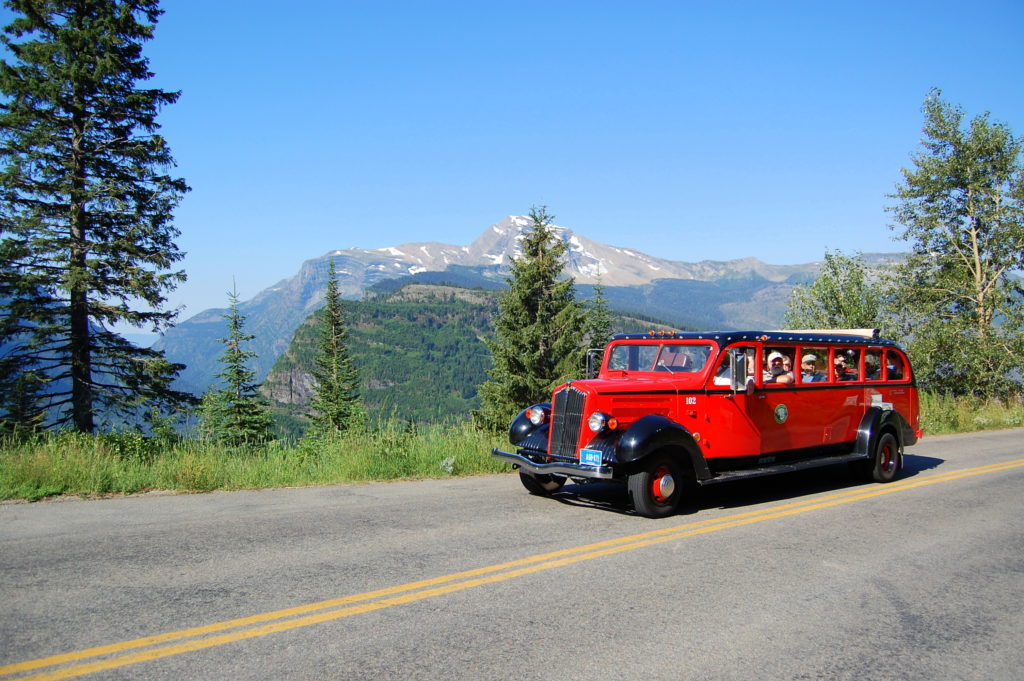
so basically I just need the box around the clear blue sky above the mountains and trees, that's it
[0,0,1024,318]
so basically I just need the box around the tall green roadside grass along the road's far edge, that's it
[0,392,1024,500]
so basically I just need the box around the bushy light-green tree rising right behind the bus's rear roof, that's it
[785,251,886,329]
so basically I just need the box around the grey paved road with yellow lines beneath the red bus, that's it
[6,430,1024,681]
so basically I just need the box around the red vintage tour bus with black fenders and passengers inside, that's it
[494,330,922,517]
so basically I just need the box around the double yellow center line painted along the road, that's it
[0,459,1024,681]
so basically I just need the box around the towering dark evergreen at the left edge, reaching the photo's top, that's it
[0,0,190,432]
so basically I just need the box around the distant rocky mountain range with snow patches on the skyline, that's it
[155,216,898,394]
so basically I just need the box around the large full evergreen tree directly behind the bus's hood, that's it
[473,207,585,430]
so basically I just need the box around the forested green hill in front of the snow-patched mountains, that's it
[263,284,679,431]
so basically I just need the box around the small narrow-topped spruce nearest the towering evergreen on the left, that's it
[200,291,273,445]
